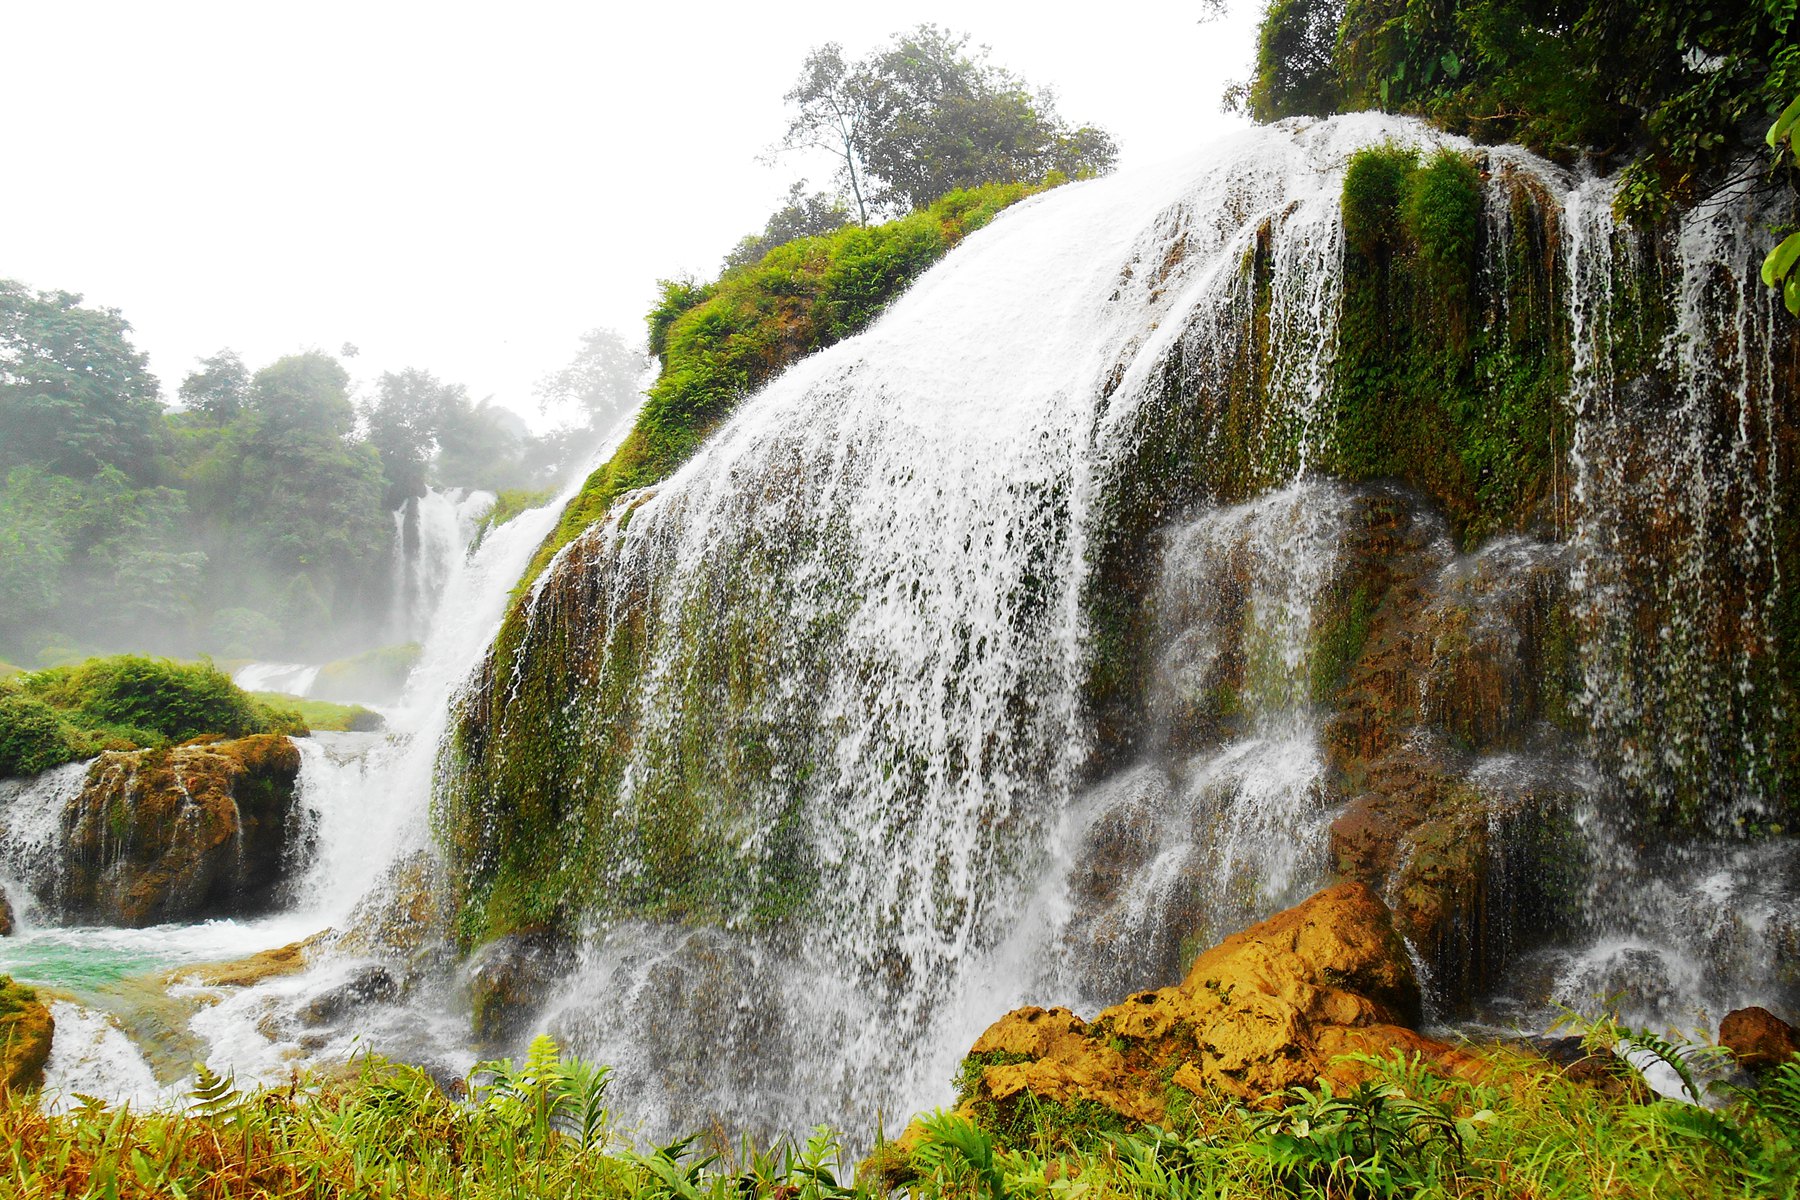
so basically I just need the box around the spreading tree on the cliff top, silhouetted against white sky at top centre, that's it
[779,25,1118,221]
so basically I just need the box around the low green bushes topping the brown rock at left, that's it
[0,655,308,777]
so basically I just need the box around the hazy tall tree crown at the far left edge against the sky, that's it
[0,279,162,480]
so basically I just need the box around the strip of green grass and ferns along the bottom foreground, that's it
[0,1038,1800,1200]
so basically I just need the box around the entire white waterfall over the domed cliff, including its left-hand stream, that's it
[0,115,1800,1135]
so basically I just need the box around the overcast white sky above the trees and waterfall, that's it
[0,0,1260,417]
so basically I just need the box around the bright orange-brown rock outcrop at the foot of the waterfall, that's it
[963,882,1476,1128]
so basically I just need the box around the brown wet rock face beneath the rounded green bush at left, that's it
[55,734,301,928]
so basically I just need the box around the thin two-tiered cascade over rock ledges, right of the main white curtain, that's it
[1066,480,1352,1004]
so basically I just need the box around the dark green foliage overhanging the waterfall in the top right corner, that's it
[1249,0,1800,218]
